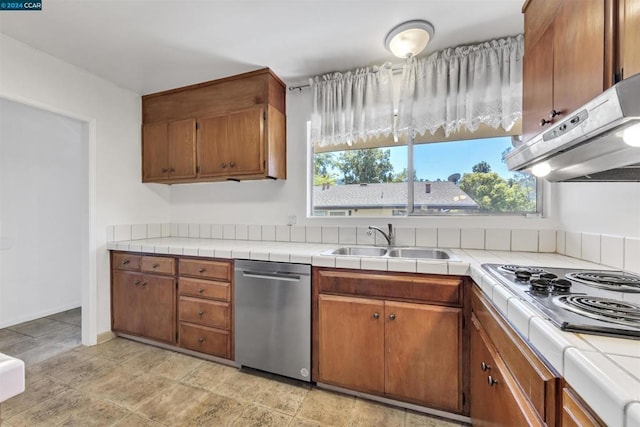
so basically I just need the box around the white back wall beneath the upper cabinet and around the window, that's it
[171,89,555,229]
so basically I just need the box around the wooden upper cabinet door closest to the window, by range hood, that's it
[522,27,553,141]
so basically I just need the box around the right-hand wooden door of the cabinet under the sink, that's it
[385,301,462,412]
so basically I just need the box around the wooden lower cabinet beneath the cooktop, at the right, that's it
[469,286,560,427]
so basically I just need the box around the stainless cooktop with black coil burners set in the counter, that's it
[482,264,640,339]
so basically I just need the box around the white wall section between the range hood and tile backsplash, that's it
[552,182,640,238]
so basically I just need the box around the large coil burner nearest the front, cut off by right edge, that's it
[553,295,640,327]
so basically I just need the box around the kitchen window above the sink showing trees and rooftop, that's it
[310,136,540,217]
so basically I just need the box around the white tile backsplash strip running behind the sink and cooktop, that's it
[107,224,640,273]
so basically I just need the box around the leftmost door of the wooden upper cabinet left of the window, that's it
[142,123,169,182]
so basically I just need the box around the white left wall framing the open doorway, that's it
[0,35,170,343]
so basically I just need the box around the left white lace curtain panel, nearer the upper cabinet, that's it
[310,63,393,147]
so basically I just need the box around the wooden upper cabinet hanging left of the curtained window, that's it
[142,69,286,183]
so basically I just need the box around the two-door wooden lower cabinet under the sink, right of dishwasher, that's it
[314,269,464,413]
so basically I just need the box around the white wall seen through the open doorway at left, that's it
[0,98,84,328]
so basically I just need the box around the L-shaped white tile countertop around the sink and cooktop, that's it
[108,237,640,426]
